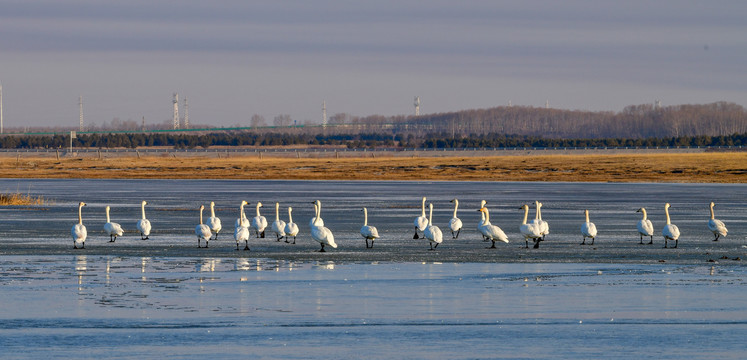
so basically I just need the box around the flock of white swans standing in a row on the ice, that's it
[71,197,728,252]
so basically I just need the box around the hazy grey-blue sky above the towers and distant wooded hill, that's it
[0,0,747,127]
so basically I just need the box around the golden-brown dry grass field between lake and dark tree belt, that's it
[0,152,747,183]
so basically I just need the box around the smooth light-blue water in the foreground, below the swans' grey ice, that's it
[0,255,747,359]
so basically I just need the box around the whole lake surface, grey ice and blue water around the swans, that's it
[0,179,747,359]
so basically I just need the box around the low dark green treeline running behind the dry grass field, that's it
[0,131,747,149]
